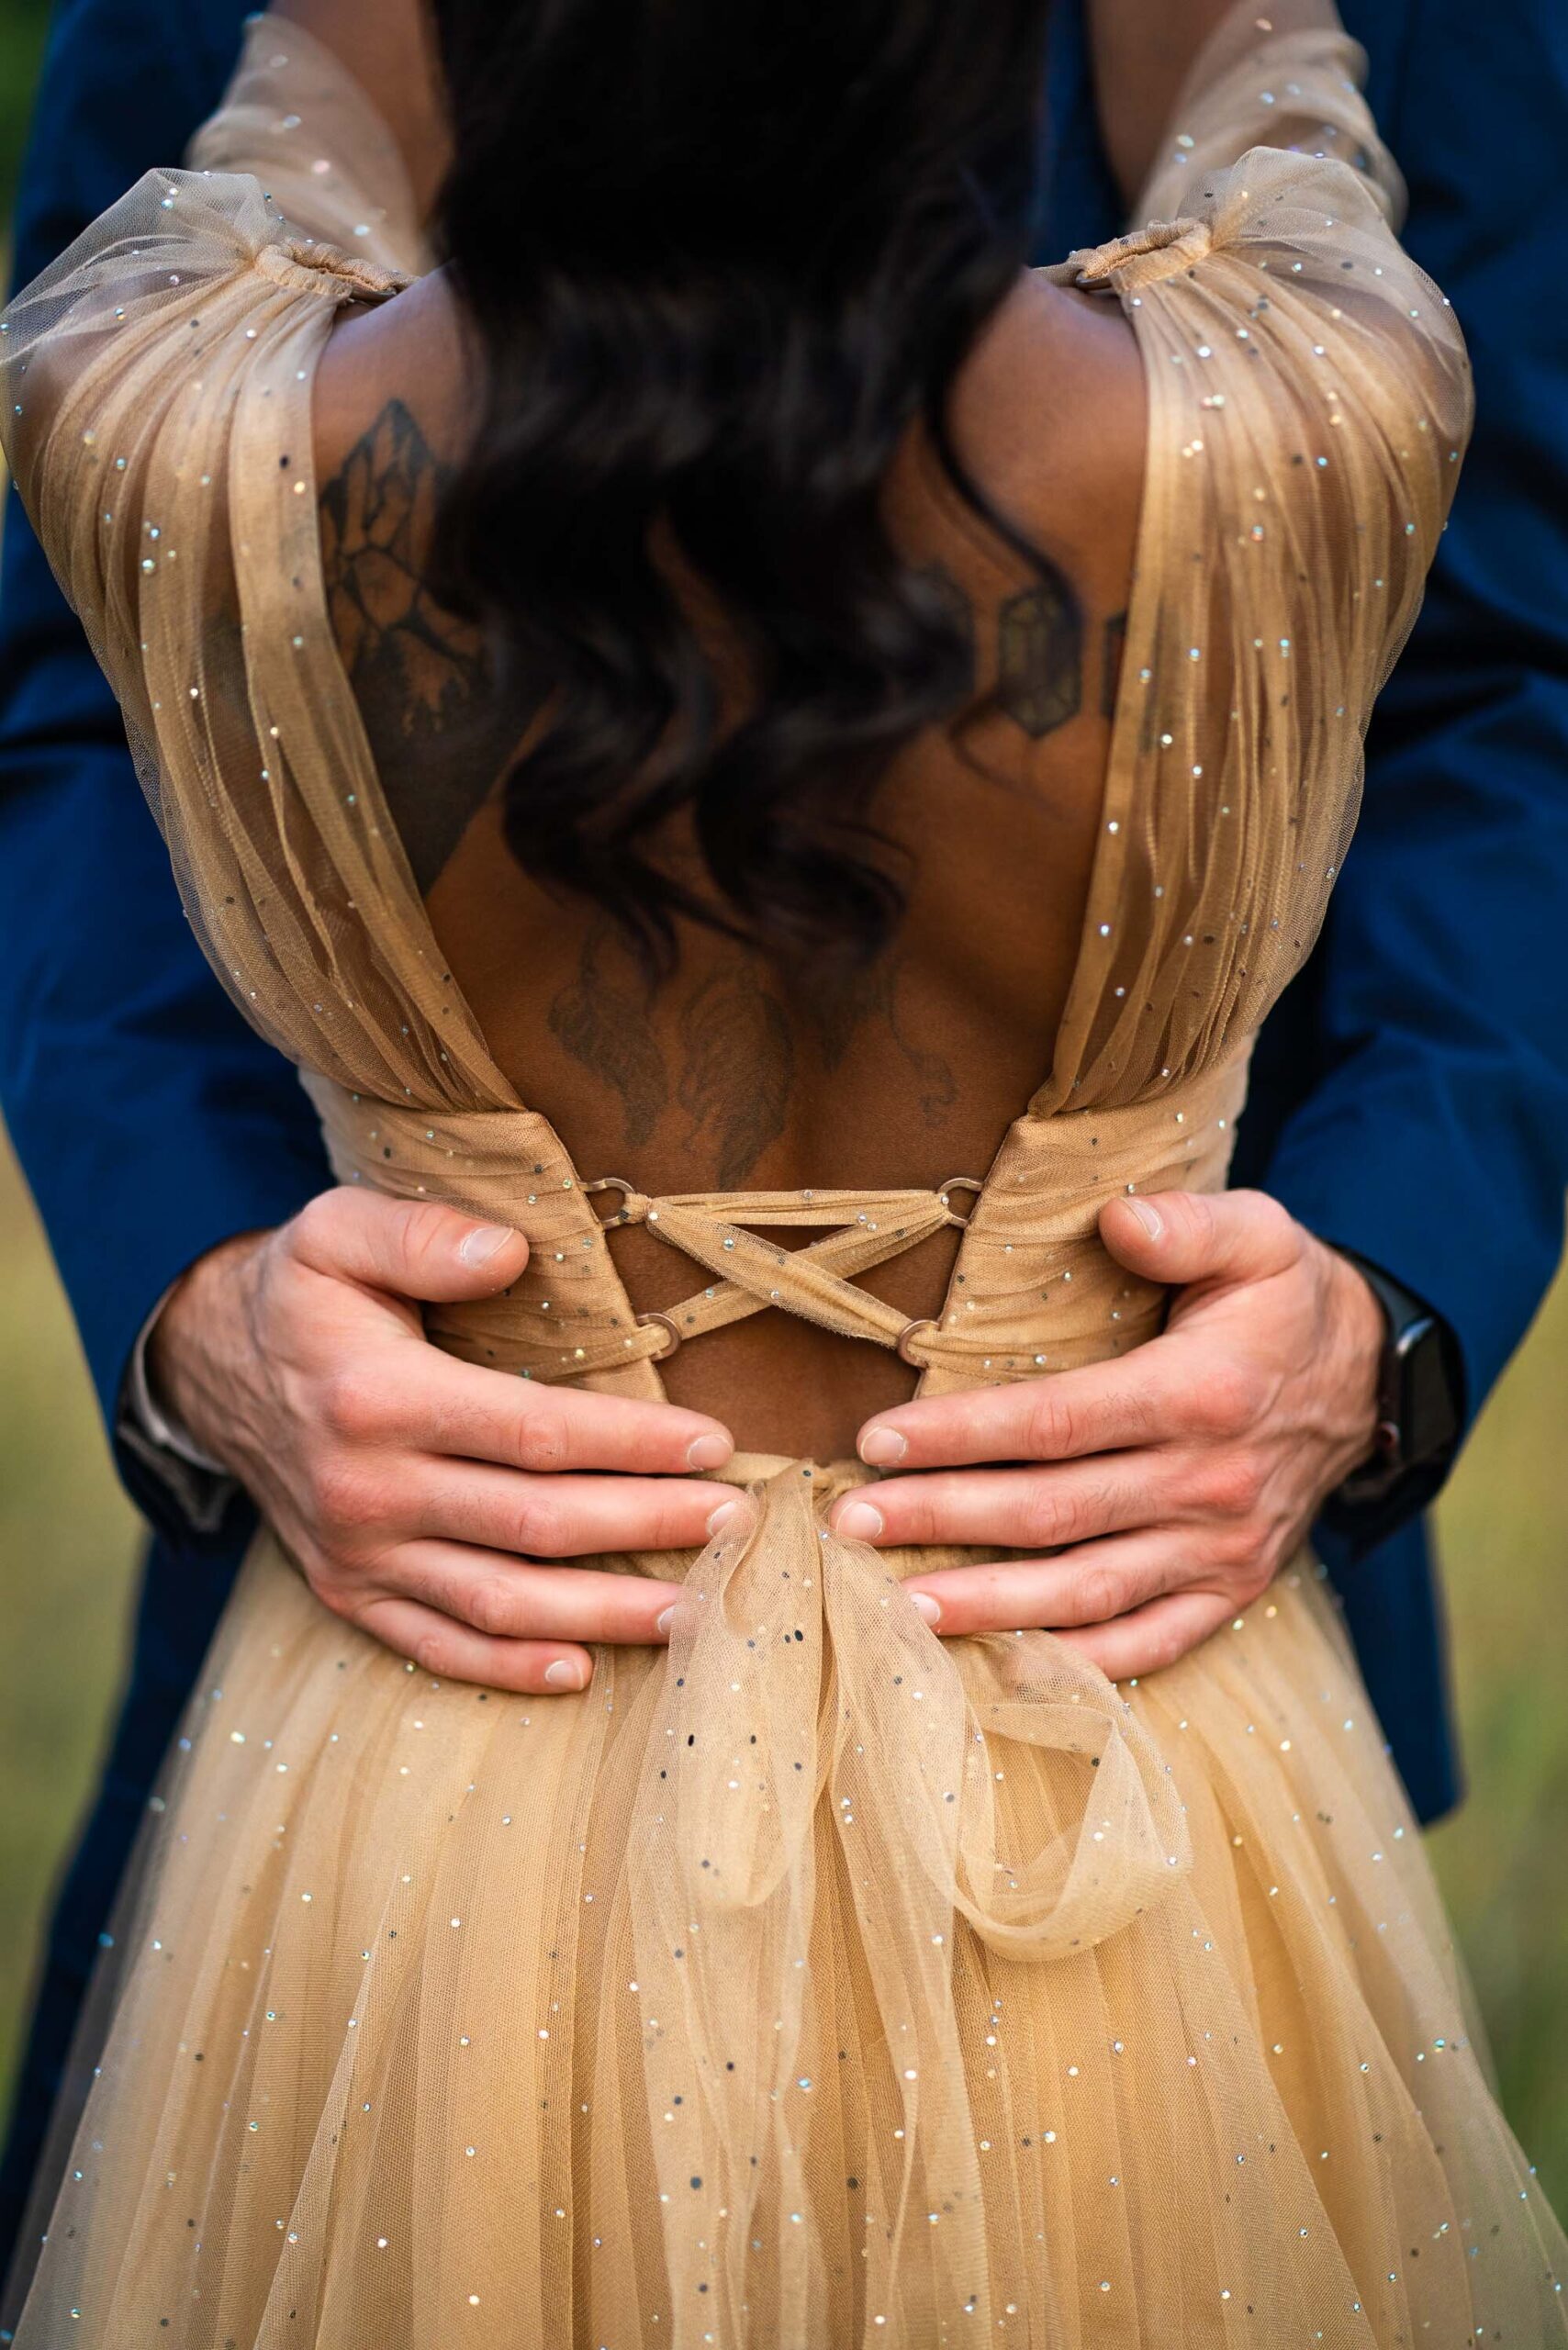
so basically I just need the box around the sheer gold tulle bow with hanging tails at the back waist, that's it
[628,1457,1192,2317]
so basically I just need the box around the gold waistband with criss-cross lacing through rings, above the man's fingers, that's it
[306,1053,1246,1393]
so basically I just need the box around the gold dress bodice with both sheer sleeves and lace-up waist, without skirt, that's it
[0,17,1469,1393]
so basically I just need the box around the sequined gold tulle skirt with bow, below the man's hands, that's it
[17,1457,1565,2350]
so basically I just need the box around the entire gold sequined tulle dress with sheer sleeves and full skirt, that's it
[5,9,1565,2350]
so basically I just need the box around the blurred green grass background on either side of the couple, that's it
[0,0,1568,2211]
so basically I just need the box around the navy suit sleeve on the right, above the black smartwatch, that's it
[1238,0,1568,1415]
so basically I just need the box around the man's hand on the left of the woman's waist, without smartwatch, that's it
[148,1187,738,1692]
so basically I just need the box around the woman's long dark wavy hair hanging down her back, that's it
[432,0,1047,968]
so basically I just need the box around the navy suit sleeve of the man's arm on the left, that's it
[0,0,331,1535]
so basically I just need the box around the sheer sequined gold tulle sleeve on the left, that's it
[0,18,510,1107]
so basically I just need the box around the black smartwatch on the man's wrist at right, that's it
[1324,1248,1464,1539]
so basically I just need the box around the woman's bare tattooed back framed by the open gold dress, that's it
[315,275,1145,1460]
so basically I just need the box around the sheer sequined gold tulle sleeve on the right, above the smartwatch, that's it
[1036,0,1472,1109]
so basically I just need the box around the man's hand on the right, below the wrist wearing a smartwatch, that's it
[832,1192,1383,1680]
